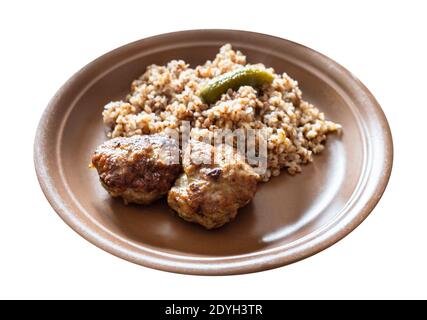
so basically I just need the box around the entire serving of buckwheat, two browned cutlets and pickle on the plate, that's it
[92,44,341,229]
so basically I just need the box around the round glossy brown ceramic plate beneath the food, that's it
[34,30,393,275]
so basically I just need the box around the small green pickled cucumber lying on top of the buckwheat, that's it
[200,67,274,104]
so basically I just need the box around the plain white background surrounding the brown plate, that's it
[0,0,427,299]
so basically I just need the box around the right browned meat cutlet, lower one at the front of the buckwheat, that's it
[168,141,259,229]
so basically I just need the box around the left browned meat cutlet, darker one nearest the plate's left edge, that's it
[92,135,182,204]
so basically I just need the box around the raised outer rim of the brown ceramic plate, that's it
[33,29,394,275]
